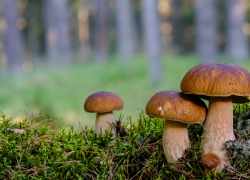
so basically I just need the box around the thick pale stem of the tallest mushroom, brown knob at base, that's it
[202,98,235,171]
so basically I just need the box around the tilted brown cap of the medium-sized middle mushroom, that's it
[146,91,207,124]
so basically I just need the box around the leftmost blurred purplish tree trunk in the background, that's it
[3,0,24,72]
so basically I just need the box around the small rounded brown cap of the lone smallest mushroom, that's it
[84,91,123,113]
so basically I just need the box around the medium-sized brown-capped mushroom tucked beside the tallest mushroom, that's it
[146,91,206,163]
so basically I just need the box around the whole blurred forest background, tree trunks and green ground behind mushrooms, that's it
[0,0,250,126]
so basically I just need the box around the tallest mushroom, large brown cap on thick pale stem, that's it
[181,64,250,171]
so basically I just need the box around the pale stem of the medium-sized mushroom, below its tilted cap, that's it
[162,121,190,163]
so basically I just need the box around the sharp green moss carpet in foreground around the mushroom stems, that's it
[0,109,250,180]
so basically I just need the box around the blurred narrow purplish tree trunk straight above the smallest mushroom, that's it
[95,0,108,62]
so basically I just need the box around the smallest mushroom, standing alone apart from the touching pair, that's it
[84,91,123,134]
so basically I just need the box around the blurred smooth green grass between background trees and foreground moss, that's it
[0,56,250,127]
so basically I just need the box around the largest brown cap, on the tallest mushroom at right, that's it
[181,64,250,103]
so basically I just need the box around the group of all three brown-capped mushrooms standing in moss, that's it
[84,64,250,171]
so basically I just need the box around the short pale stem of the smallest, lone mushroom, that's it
[95,112,115,134]
